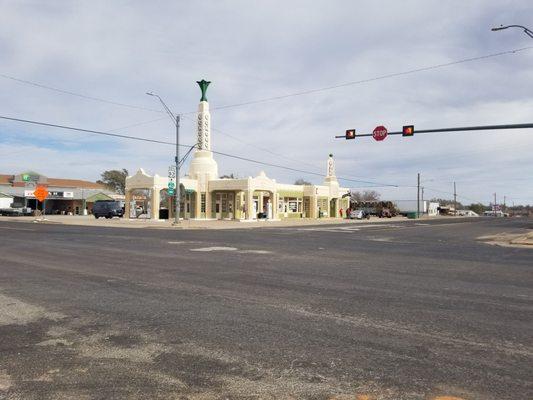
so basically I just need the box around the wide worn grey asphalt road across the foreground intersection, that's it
[0,218,533,400]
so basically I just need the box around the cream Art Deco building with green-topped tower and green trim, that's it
[125,81,349,220]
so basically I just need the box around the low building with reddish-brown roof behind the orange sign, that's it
[0,171,114,215]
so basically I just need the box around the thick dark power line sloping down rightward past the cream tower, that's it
[0,115,398,187]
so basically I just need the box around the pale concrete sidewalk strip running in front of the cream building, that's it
[0,215,416,229]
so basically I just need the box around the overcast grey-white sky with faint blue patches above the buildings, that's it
[0,0,533,205]
